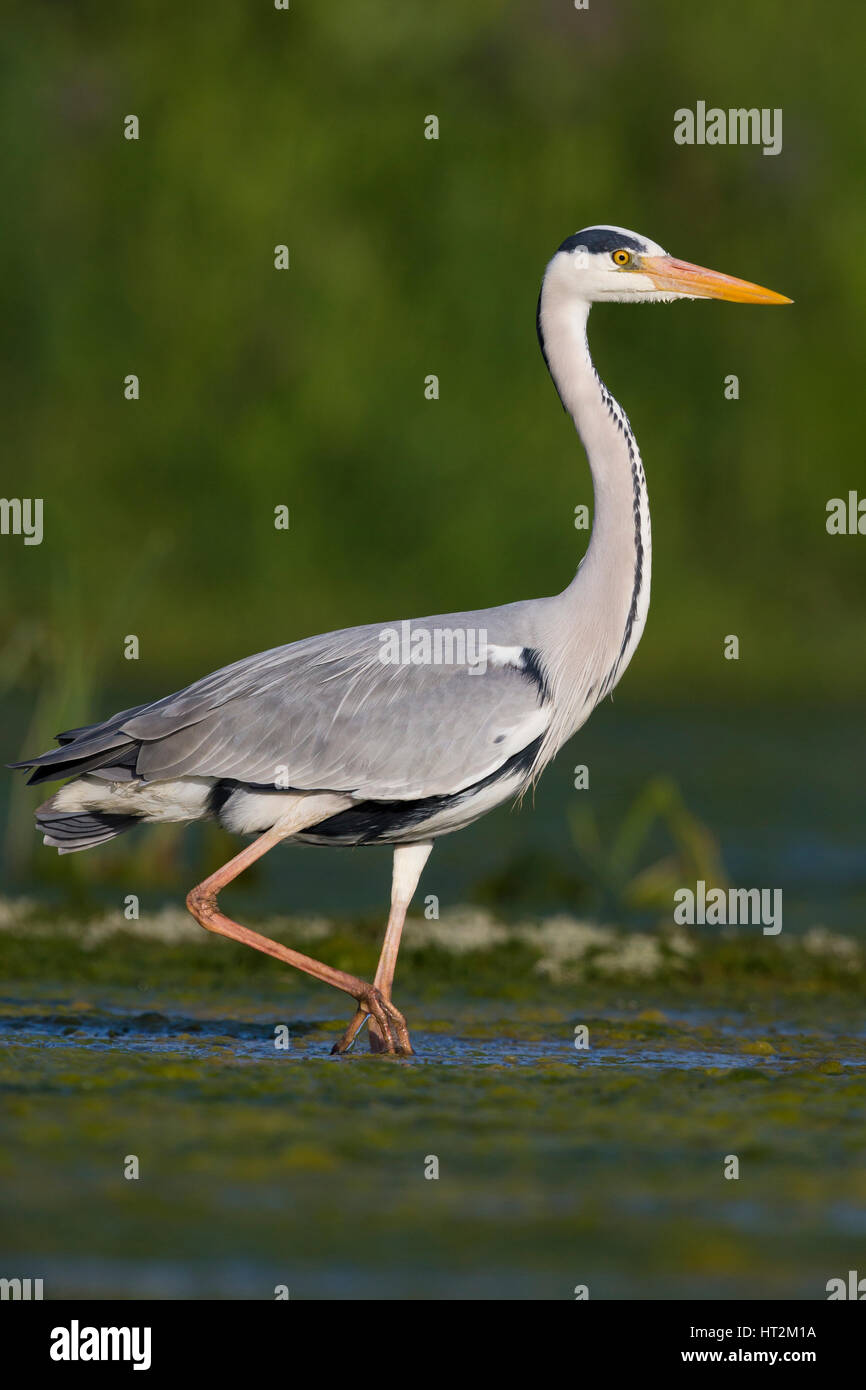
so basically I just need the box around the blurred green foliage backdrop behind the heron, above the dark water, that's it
[0,0,866,900]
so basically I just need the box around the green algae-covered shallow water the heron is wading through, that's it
[0,927,866,1298]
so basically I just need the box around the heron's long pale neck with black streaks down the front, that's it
[538,282,652,727]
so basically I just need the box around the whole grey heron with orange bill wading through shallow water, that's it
[14,225,791,1054]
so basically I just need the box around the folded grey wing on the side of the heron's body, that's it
[116,610,549,801]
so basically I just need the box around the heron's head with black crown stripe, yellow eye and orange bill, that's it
[545,227,791,304]
